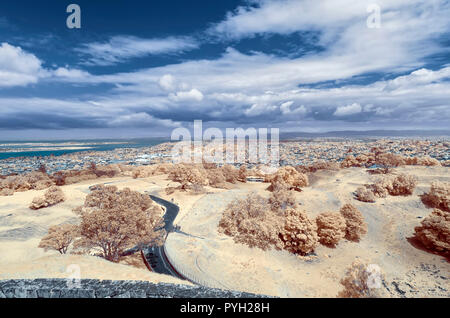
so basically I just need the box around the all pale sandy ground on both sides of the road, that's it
[0,167,450,297]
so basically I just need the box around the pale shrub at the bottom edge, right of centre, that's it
[338,261,384,298]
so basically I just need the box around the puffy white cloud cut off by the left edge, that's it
[0,43,43,87]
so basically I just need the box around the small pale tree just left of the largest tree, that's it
[38,224,78,254]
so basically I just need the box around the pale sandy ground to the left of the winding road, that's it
[0,176,186,284]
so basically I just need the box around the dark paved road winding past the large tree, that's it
[143,195,186,280]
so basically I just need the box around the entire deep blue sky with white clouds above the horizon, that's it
[0,0,450,140]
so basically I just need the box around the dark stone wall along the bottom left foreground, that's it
[0,279,266,298]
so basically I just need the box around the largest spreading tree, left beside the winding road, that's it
[75,185,165,262]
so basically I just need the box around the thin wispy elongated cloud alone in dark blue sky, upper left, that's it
[76,36,198,66]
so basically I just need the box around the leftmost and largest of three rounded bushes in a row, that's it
[280,208,318,255]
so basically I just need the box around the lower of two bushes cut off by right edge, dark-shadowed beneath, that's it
[415,209,450,254]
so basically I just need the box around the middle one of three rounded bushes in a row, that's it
[316,212,346,247]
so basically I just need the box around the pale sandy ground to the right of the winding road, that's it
[166,167,450,297]
